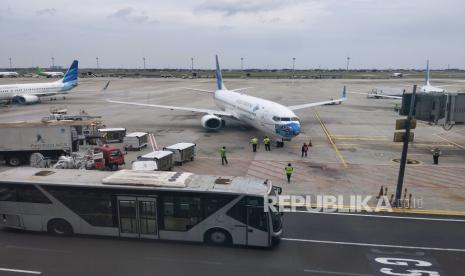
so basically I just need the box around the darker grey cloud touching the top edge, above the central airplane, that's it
[196,0,296,16]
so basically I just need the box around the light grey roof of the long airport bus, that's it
[0,167,271,196]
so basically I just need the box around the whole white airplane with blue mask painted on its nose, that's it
[107,56,347,146]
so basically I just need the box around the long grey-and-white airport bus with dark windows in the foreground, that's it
[0,168,282,247]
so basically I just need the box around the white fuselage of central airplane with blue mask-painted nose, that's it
[214,90,300,140]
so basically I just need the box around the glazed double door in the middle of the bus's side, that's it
[117,196,158,239]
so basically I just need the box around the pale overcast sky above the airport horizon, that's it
[0,0,465,69]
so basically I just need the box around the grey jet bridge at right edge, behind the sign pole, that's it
[399,92,465,130]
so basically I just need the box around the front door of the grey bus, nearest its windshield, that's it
[246,205,271,246]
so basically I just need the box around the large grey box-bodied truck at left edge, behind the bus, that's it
[0,122,78,166]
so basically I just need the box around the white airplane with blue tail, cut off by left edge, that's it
[0,60,78,104]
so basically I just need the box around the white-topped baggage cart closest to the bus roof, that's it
[132,150,173,171]
